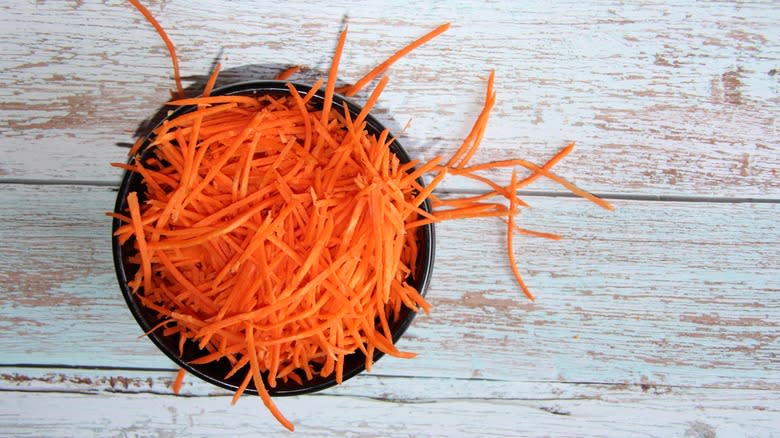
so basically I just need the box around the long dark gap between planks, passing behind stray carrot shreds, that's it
[0,178,780,204]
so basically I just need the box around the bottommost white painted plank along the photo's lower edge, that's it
[0,389,780,437]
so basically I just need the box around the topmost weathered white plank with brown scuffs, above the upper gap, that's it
[0,1,780,197]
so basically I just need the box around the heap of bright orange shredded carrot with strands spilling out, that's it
[111,0,612,430]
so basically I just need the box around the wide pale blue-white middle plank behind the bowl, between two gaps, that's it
[0,185,780,389]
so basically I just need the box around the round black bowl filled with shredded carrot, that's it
[112,81,434,396]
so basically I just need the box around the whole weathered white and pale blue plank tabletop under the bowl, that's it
[0,0,780,437]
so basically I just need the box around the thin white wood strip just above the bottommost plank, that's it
[0,366,780,404]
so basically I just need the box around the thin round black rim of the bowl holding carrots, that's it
[111,80,436,396]
